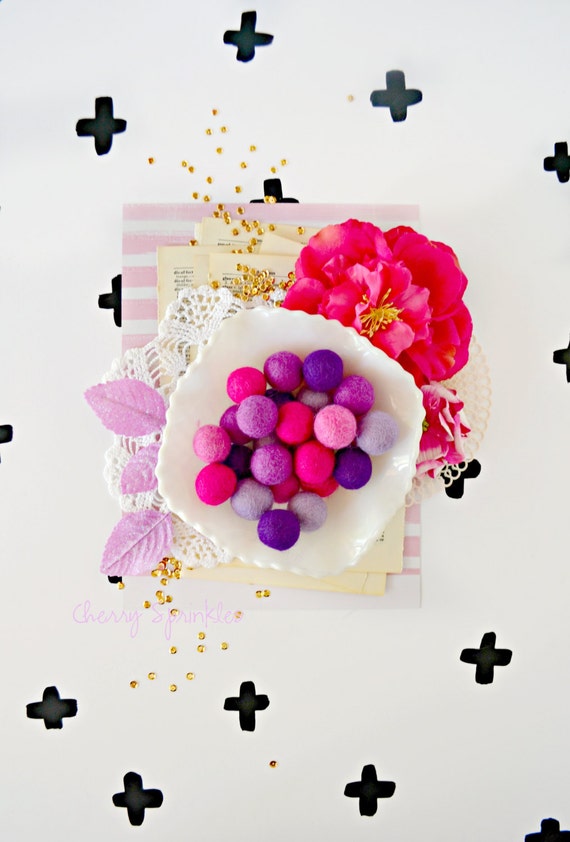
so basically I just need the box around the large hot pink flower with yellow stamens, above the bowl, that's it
[283,219,472,386]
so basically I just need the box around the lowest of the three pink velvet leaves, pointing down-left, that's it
[101,509,172,576]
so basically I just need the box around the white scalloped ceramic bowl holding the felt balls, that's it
[156,307,424,576]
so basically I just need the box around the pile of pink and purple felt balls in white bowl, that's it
[193,349,398,551]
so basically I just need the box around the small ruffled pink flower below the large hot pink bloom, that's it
[417,383,470,477]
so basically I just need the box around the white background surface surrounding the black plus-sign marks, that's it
[0,0,570,842]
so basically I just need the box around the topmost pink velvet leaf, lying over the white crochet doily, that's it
[85,377,166,436]
